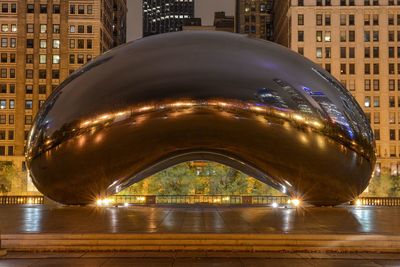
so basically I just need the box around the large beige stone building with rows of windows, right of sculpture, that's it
[274,0,400,176]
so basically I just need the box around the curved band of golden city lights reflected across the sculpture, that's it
[28,97,357,163]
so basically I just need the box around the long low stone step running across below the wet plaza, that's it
[1,234,400,253]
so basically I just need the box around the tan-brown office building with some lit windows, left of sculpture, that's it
[0,0,127,192]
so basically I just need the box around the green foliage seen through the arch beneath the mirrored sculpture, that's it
[120,162,282,195]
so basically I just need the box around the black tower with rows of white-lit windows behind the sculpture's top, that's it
[143,0,195,37]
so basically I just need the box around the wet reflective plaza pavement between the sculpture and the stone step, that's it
[0,205,400,235]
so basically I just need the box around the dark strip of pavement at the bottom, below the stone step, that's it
[0,252,400,267]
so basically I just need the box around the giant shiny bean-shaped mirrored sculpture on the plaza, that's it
[26,32,375,205]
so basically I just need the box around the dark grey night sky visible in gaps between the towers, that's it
[127,0,235,41]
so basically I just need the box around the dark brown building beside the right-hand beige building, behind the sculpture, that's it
[236,0,274,40]
